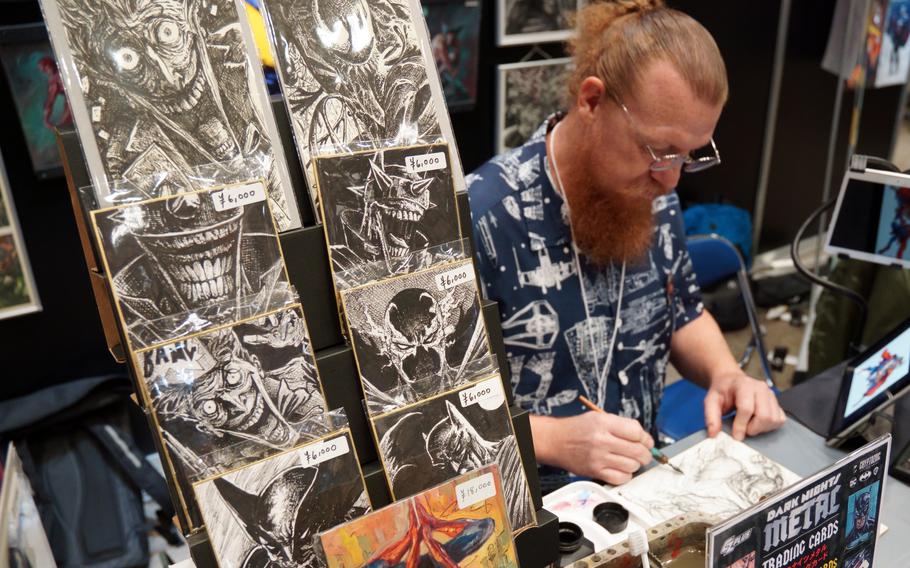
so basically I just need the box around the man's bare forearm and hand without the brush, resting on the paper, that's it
[670,311,787,440]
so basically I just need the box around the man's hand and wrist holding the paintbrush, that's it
[531,412,654,485]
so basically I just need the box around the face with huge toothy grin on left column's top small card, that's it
[123,194,243,309]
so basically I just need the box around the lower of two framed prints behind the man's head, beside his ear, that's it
[496,57,572,154]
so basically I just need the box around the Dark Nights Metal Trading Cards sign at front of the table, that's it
[708,435,891,568]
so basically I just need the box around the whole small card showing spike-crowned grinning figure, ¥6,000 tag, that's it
[315,144,461,275]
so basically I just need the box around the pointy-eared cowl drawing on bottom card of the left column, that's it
[194,430,370,568]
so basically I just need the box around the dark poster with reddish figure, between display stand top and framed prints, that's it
[423,0,480,111]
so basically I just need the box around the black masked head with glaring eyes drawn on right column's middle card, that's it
[384,288,446,388]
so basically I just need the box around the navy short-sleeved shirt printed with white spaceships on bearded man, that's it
[467,123,703,487]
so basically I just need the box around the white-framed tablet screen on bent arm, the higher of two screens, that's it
[828,176,910,264]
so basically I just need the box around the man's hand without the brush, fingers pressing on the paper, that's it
[705,371,787,440]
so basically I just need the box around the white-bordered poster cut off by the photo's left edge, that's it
[0,152,41,319]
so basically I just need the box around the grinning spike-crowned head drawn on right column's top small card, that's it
[362,153,433,260]
